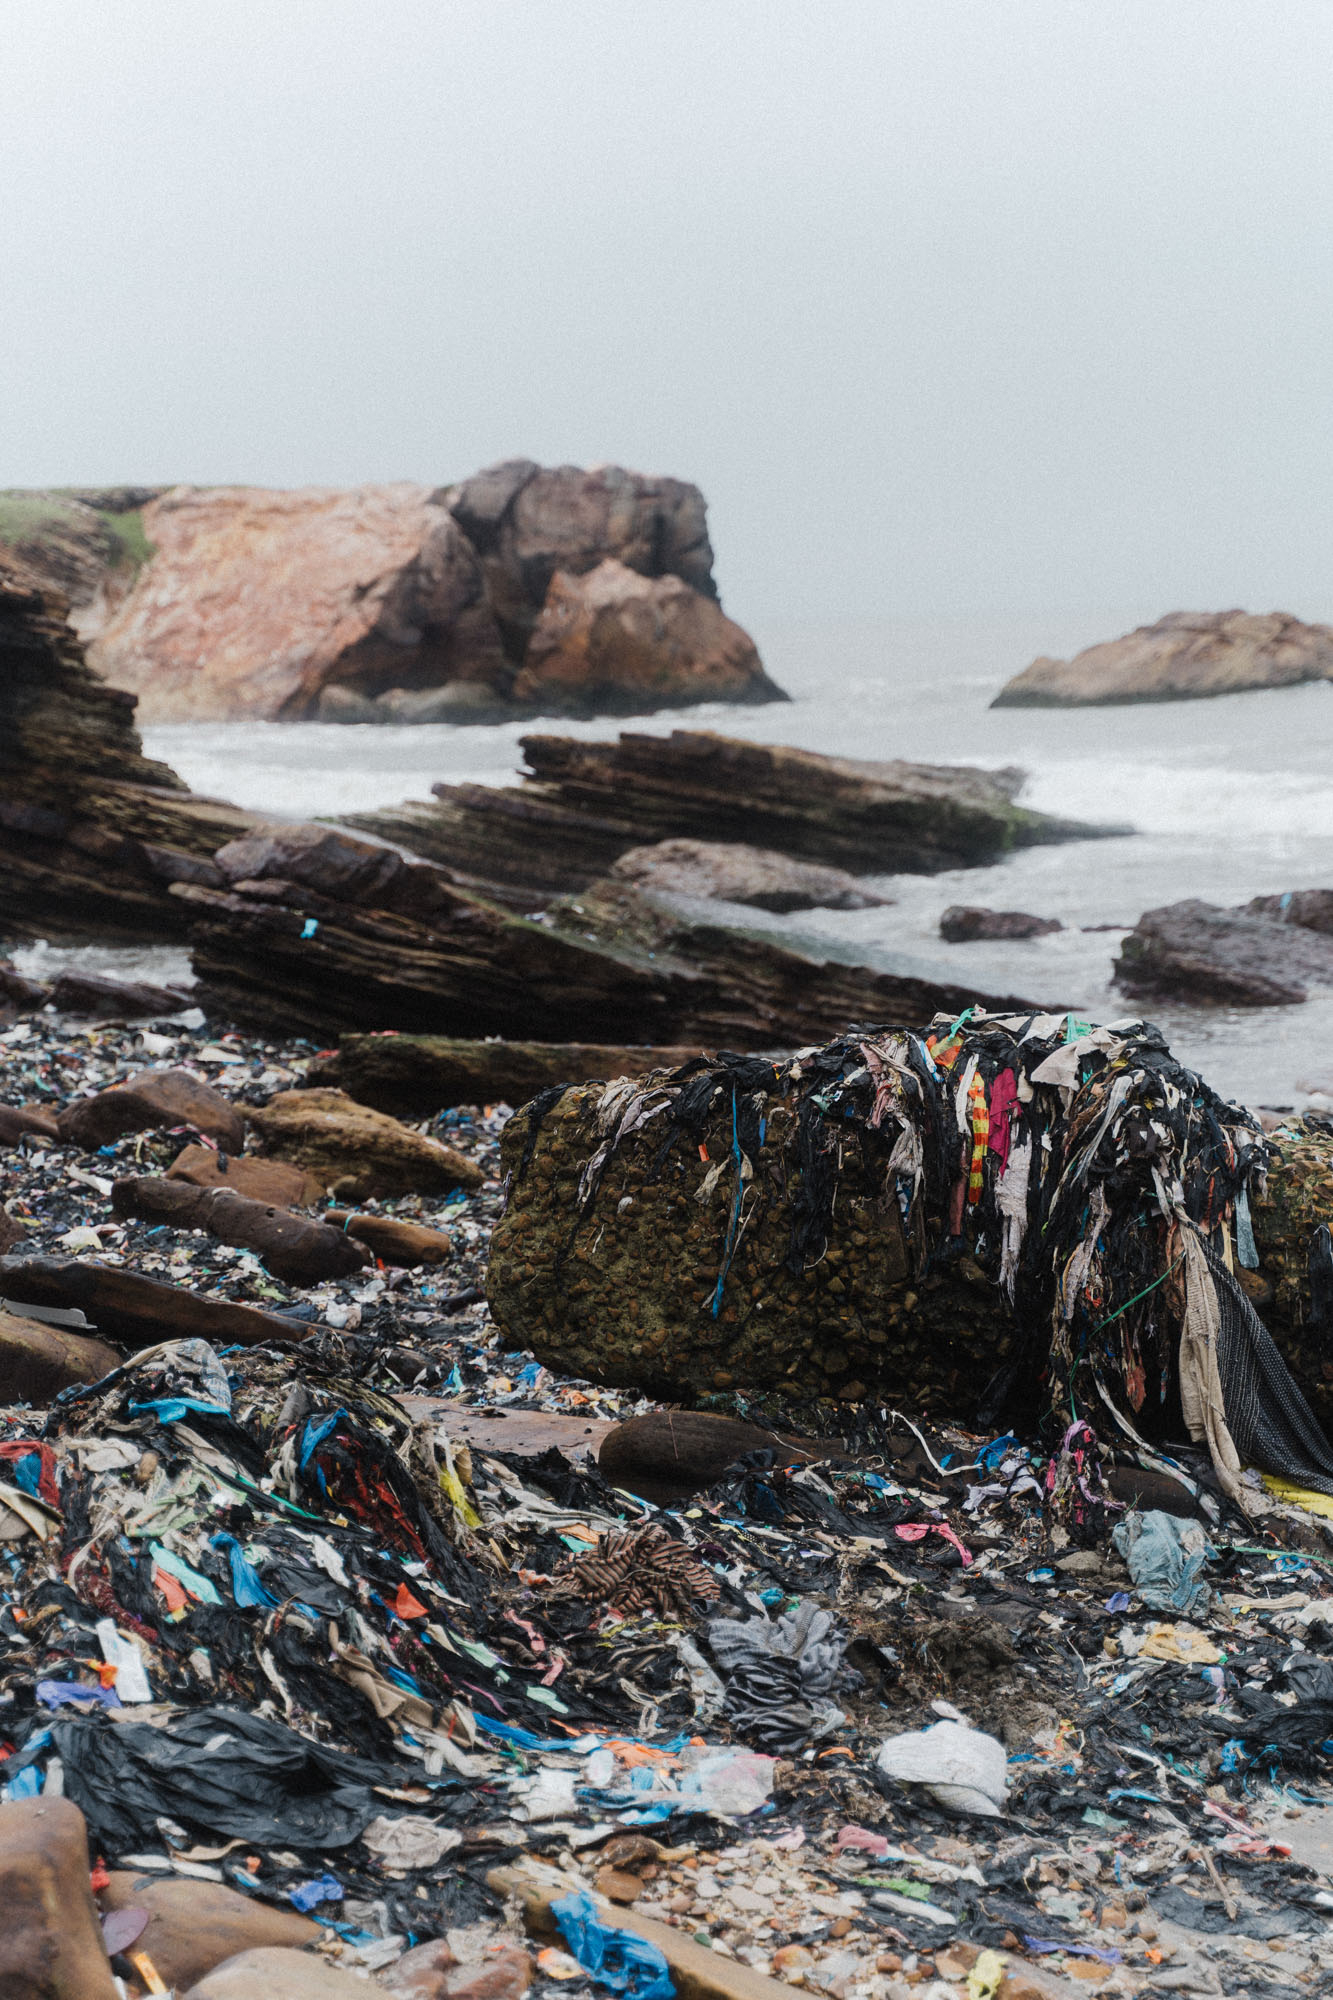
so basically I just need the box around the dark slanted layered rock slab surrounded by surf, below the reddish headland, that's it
[350,730,1123,910]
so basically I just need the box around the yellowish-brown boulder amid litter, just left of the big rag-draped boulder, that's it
[250,1090,482,1202]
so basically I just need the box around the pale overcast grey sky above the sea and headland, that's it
[0,0,1333,622]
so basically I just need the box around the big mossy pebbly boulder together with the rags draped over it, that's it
[488,1008,1333,1506]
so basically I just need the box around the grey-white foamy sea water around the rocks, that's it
[122,606,1333,1106]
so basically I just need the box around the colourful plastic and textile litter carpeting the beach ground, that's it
[0,1020,1333,2000]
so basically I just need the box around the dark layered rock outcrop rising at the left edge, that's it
[0,550,254,938]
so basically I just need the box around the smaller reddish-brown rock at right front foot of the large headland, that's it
[514,556,785,716]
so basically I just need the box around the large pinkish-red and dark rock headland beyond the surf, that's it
[83,460,779,722]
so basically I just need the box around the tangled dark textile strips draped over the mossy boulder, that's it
[556,1008,1333,1512]
